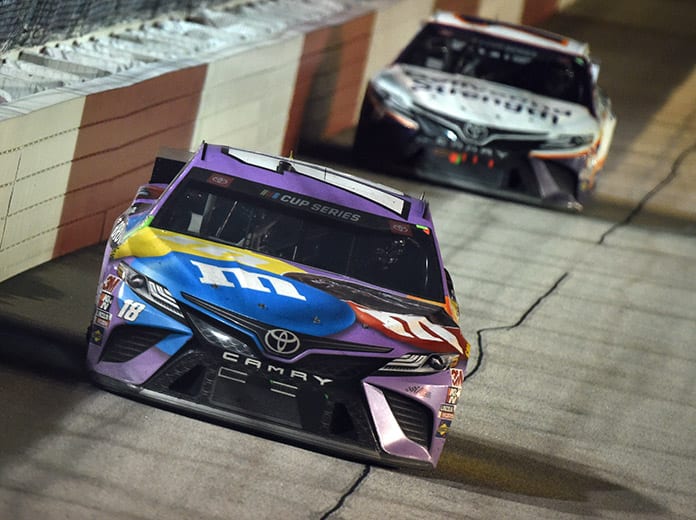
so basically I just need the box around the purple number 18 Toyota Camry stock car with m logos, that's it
[87,143,470,467]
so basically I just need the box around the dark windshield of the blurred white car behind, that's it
[396,24,592,108]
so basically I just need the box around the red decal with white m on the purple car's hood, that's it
[348,302,470,358]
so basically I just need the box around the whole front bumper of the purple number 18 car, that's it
[88,300,458,468]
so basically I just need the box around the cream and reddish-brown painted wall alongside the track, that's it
[0,0,570,281]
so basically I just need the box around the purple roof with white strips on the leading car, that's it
[182,143,431,222]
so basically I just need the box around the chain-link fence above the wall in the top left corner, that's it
[0,0,230,55]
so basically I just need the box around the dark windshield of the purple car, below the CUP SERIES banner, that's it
[151,176,444,301]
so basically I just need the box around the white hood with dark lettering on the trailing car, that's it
[373,63,598,137]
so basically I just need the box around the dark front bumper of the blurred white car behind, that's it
[354,100,591,211]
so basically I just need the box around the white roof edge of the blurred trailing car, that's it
[428,11,590,59]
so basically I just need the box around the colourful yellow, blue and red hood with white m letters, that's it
[113,227,467,352]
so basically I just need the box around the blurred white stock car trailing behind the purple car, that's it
[354,12,616,211]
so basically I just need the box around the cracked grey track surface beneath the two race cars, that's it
[0,0,696,519]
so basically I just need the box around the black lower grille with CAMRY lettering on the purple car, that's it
[145,339,382,449]
